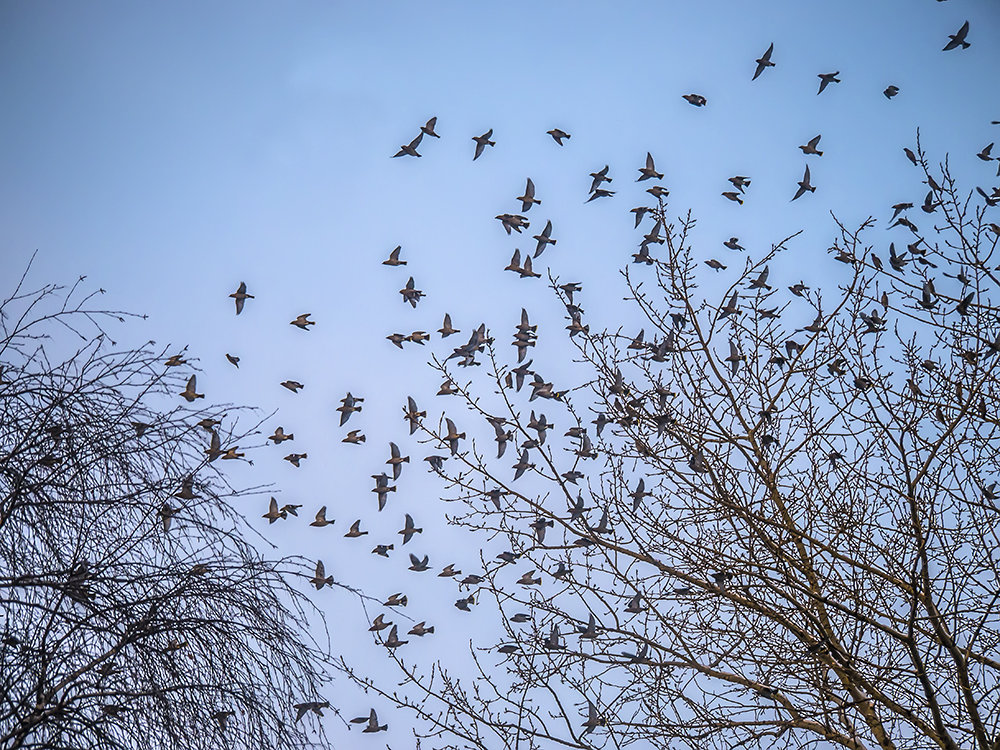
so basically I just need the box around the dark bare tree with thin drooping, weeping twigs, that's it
[0,268,338,748]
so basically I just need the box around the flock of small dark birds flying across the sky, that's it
[154,16,1000,733]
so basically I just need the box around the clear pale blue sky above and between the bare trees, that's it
[0,0,1000,744]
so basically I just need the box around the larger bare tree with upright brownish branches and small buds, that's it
[354,143,1000,750]
